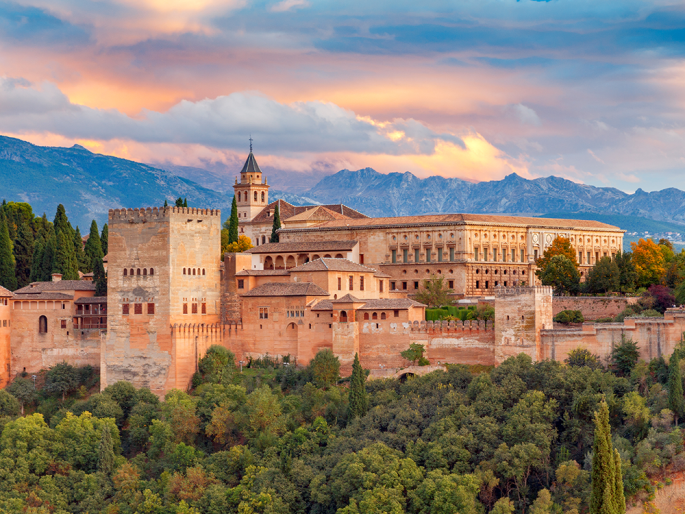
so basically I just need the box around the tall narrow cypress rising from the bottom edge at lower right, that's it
[590,400,626,514]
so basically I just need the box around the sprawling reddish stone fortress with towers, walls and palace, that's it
[0,148,685,395]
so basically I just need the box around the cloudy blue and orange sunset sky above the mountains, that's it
[0,0,685,192]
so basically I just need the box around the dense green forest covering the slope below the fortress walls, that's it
[0,340,685,514]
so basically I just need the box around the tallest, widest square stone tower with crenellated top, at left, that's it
[101,207,221,396]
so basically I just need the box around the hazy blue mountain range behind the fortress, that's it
[0,132,685,240]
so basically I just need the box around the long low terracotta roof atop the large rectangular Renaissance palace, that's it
[281,214,624,232]
